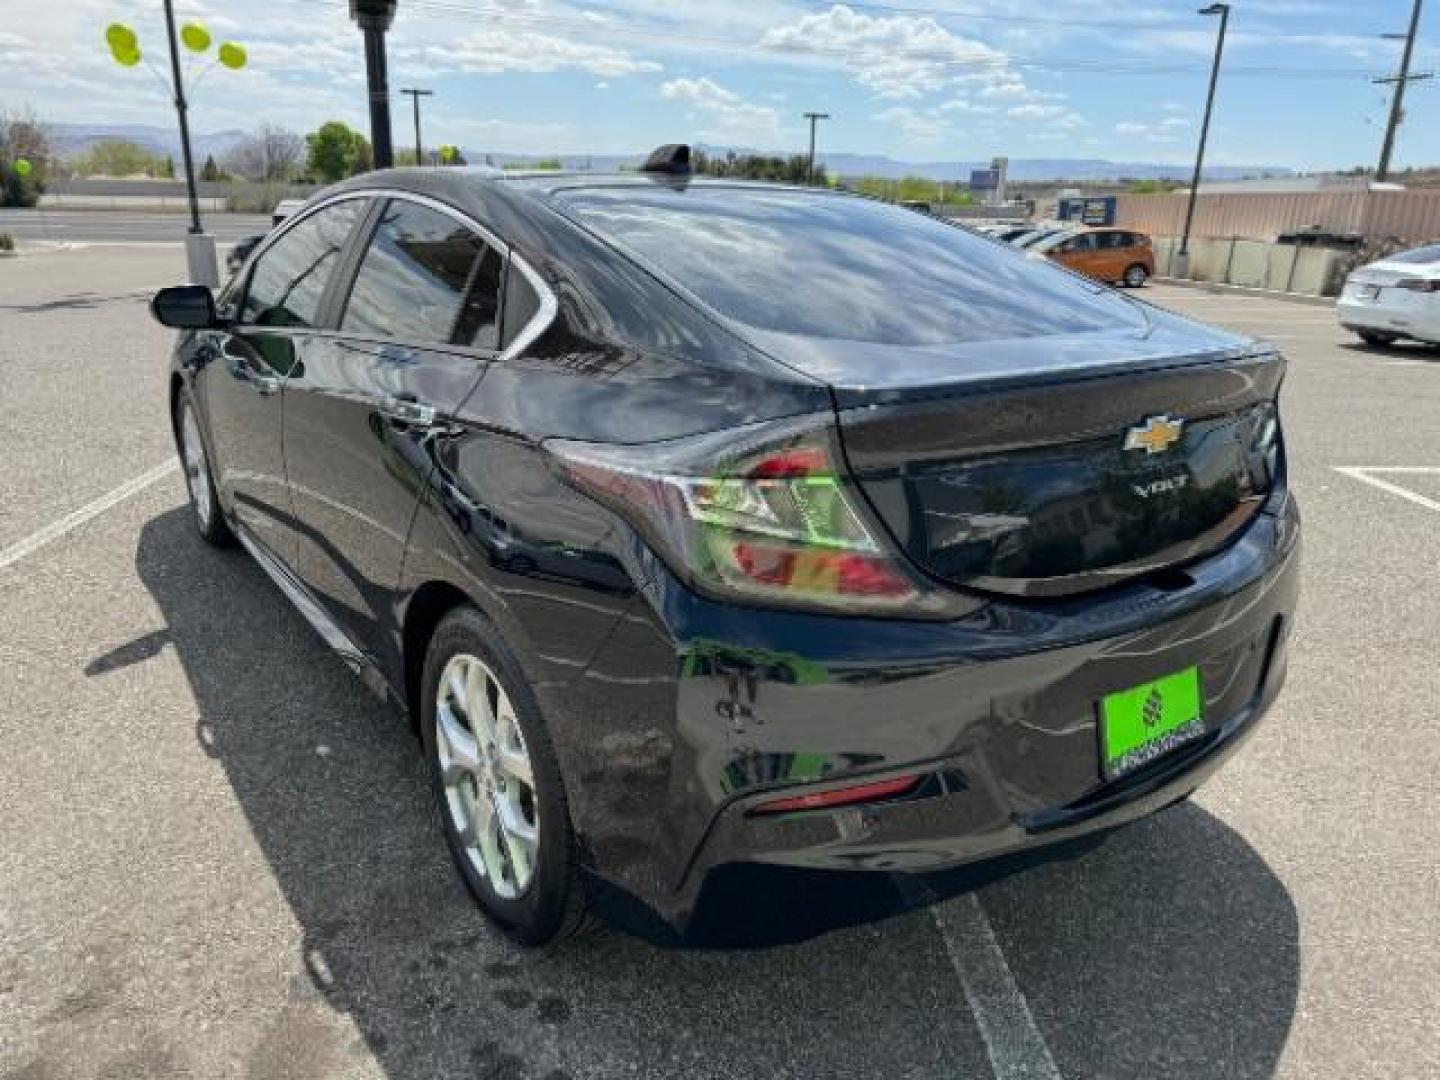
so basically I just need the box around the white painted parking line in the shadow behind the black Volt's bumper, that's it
[930,893,1060,1080]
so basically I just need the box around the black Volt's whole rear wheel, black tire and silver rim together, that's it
[420,606,585,945]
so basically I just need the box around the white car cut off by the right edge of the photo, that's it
[1335,243,1440,346]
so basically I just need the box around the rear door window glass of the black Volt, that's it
[340,199,504,348]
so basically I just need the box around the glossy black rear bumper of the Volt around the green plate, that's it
[555,501,1299,930]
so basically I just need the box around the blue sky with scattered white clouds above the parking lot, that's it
[0,0,1440,168]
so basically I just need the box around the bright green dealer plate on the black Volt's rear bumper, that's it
[1100,668,1205,779]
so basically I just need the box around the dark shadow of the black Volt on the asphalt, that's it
[109,507,1299,1080]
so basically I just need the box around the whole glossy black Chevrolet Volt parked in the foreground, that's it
[151,147,1299,943]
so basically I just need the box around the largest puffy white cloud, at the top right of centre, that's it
[760,4,1018,98]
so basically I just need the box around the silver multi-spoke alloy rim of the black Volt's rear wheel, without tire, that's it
[435,652,540,900]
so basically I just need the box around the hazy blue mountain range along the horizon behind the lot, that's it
[50,124,1295,183]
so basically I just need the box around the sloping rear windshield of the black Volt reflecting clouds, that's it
[557,186,1145,346]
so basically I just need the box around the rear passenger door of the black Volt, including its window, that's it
[285,194,505,672]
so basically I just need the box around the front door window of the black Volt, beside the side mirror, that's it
[240,199,364,327]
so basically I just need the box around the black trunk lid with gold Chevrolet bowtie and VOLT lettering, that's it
[837,331,1284,596]
